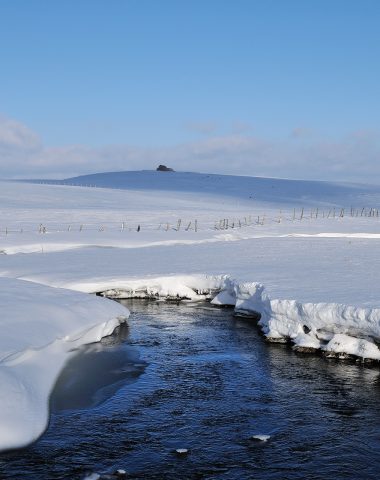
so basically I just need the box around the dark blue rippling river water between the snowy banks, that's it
[0,301,380,480]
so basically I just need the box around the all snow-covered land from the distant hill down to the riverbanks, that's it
[0,171,380,449]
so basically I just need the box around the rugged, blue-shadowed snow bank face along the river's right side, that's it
[211,279,380,360]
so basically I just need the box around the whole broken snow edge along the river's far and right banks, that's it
[96,275,380,361]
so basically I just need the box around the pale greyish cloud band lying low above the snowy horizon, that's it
[0,118,380,183]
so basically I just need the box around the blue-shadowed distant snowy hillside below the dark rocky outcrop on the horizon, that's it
[34,170,380,207]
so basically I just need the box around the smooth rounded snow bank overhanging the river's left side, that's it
[0,278,129,450]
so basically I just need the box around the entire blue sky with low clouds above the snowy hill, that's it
[0,0,380,182]
